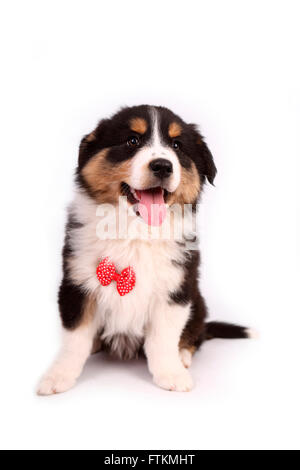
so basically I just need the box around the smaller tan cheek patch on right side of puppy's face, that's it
[169,162,201,206]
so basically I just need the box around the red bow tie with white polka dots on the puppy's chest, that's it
[97,258,135,296]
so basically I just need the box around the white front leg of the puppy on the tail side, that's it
[145,304,193,392]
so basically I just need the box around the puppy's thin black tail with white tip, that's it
[205,321,256,340]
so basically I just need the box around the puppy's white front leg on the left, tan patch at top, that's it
[37,288,98,395]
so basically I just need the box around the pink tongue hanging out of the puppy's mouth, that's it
[137,188,167,227]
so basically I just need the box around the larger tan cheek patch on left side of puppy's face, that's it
[81,149,131,204]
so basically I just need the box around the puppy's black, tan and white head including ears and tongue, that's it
[77,105,216,225]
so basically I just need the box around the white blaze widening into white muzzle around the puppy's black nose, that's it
[130,108,181,192]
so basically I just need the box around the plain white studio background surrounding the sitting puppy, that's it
[0,0,300,449]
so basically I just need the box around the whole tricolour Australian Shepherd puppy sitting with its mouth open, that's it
[38,105,248,395]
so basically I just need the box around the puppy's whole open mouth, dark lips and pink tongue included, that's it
[121,183,169,226]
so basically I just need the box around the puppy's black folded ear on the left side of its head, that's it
[78,119,109,170]
